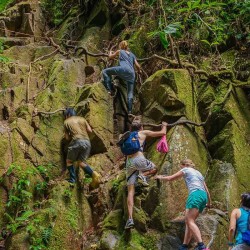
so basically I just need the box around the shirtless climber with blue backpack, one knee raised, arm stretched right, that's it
[118,121,167,229]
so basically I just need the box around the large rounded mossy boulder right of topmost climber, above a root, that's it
[139,69,200,128]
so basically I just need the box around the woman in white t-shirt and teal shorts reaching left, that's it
[155,159,211,250]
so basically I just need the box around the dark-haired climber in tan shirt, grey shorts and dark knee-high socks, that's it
[64,108,101,188]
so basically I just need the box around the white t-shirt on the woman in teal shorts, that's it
[181,167,206,194]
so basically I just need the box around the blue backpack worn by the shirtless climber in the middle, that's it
[117,131,141,155]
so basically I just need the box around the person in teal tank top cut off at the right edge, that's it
[228,192,250,250]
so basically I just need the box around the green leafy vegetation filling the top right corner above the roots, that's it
[147,0,250,52]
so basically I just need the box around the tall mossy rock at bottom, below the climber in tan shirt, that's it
[48,181,92,250]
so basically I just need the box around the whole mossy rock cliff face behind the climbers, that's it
[0,0,250,250]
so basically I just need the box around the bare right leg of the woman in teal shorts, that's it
[185,208,202,242]
